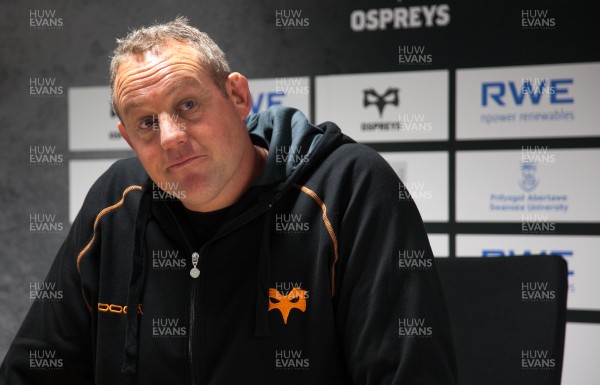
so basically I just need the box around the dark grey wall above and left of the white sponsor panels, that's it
[0,0,600,359]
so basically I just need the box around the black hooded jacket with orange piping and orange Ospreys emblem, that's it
[0,107,456,385]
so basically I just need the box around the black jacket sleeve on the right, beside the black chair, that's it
[334,149,456,385]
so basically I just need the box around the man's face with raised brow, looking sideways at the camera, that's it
[114,42,255,211]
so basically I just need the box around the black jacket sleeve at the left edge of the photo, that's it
[0,185,98,385]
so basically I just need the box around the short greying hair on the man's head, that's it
[110,16,231,118]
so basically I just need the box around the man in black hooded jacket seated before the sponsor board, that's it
[0,18,456,385]
